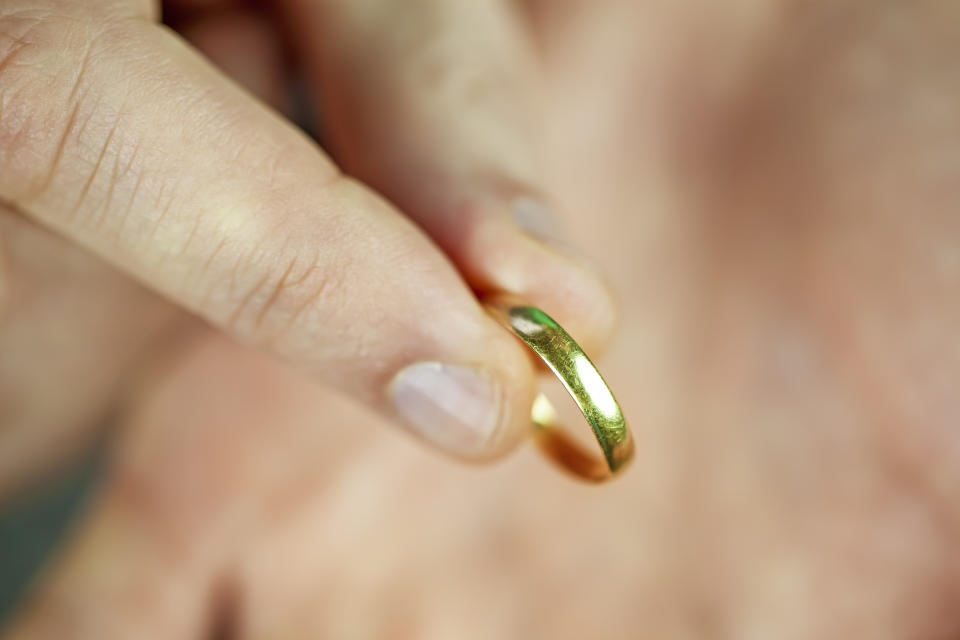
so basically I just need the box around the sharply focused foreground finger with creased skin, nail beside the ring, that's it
[0,2,532,456]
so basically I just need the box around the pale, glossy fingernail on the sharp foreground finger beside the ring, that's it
[390,362,500,455]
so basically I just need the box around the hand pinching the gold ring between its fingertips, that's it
[0,0,613,498]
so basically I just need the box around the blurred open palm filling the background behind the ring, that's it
[0,0,960,640]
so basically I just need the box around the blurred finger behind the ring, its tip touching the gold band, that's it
[287,0,615,356]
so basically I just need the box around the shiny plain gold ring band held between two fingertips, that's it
[484,296,633,482]
